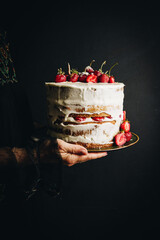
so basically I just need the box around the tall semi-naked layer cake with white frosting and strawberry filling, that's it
[45,81,124,148]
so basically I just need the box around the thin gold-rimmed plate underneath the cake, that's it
[88,132,139,152]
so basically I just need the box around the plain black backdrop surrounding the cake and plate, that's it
[1,1,160,239]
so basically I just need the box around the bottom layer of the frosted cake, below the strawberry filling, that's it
[49,121,120,144]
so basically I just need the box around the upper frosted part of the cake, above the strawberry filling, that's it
[45,82,124,124]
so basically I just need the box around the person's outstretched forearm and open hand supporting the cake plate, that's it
[0,139,107,166]
